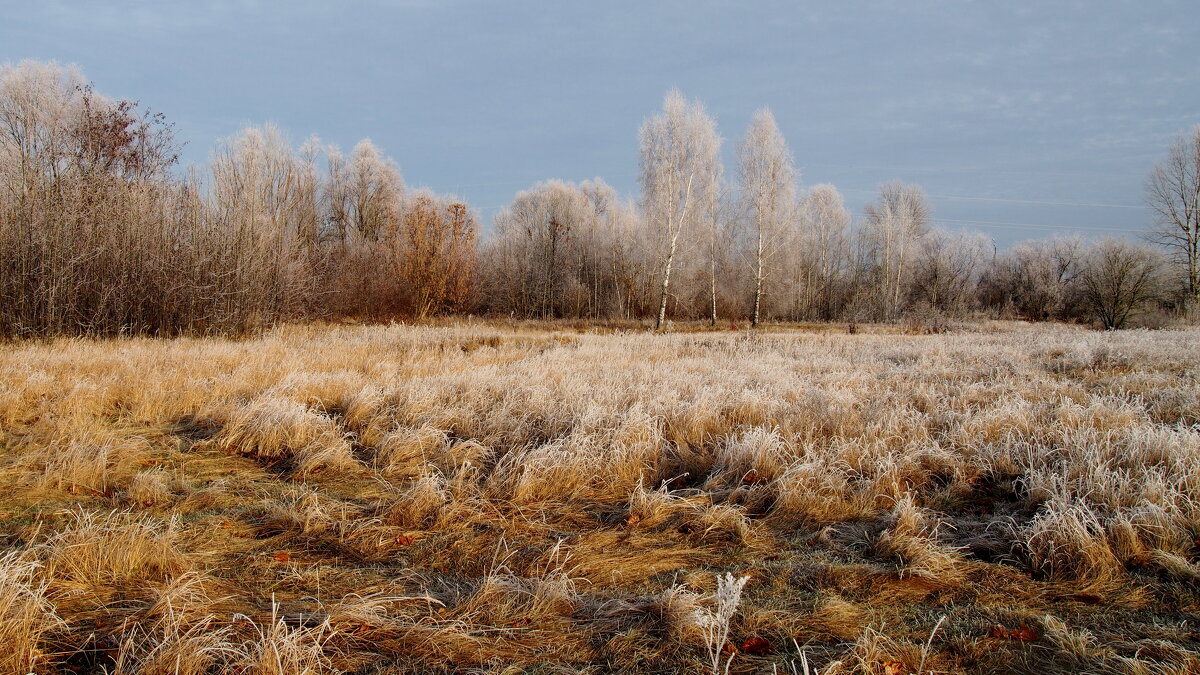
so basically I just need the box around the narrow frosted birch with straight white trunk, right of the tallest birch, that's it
[738,108,796,325]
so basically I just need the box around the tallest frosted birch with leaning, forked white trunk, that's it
[640,89,721,330]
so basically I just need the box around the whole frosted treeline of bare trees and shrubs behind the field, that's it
[0,61,1200,336]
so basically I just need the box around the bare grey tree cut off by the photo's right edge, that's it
[1146,125,1200,304]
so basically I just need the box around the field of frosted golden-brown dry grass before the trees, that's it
[0,323,1200,675]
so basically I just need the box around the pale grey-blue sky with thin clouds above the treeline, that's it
[0,0,1200,247]
